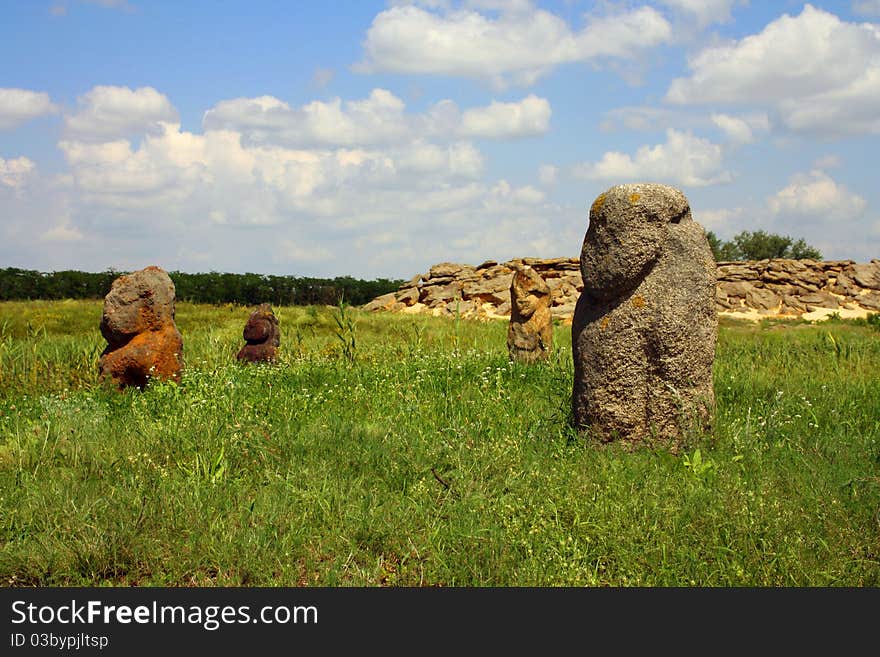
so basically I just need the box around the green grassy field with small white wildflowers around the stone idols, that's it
[0,301,880,586]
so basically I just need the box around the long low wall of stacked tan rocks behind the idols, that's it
[363,258,880,323]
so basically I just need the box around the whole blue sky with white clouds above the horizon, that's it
[0,0,880,279]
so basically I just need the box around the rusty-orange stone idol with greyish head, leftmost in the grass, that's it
[98,267,183,389]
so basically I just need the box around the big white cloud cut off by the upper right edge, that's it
[666,4,880,134]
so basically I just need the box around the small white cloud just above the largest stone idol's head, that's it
[574,129,731,187]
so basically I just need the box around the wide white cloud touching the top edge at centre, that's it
[355,2,672,87]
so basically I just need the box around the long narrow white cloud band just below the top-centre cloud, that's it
[203,89,551,147]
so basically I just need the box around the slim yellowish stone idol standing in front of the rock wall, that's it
[507,265,553,363]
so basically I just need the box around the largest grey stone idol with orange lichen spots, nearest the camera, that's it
[572,183,718,451]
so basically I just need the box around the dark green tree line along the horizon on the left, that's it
[0,267,404,306]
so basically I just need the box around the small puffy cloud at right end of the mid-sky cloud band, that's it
[460,95,551,139]
